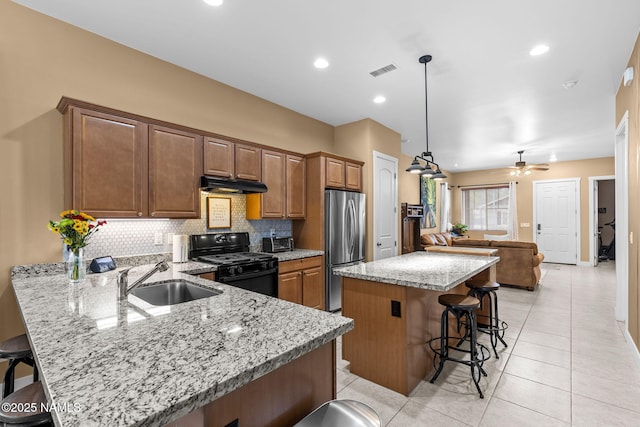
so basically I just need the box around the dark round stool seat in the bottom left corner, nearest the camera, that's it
[0,381,53,427]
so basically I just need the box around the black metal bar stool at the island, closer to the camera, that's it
[427,294,491,399]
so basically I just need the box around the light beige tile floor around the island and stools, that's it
[337,261,640,427]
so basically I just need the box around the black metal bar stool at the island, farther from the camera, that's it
[465,281,509,359]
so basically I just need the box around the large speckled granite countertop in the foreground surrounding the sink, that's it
[12,260,353,427]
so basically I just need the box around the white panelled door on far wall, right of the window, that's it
[533,179,579,264]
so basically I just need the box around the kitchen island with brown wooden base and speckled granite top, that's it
[334,252,500,396]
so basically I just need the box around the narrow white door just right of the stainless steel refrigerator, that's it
[373,151,398,260]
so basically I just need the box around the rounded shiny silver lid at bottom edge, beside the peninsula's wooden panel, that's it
[294,400,381,427]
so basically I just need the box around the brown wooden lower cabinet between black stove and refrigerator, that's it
[278,256,324,310]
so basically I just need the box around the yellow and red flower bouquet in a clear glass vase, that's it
[49,209,107,283]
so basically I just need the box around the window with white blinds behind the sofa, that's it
[462,186,509,230]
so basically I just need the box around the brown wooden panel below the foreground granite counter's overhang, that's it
[167,341,336,427]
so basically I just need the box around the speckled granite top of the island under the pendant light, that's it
[333,251,500,292]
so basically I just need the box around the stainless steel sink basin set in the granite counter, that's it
[130,279,222,305]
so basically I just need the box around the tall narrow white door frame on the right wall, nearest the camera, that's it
[614,111,629,322]
